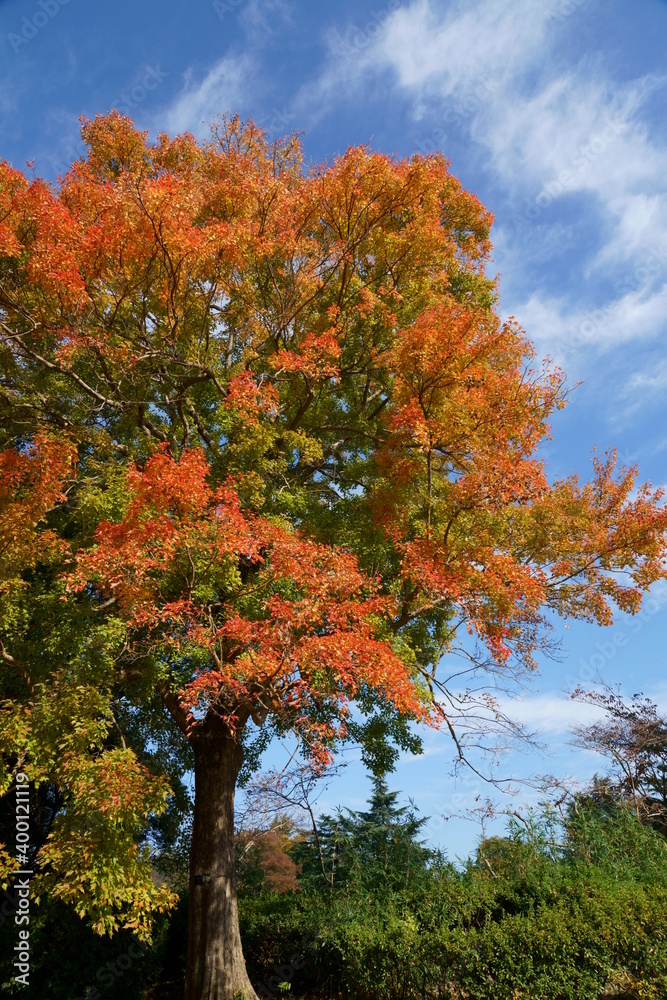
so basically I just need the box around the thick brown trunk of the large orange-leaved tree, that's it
[185,727,257,1000]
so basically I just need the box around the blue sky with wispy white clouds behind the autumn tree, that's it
[0,0,667,855]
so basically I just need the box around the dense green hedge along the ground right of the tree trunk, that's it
[236,801,667,1000]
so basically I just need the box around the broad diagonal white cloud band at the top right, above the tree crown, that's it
[374,0,667,266]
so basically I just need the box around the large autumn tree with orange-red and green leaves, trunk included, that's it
[0,113,667,1000]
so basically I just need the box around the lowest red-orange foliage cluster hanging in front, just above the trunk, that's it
[73,449,429,759]
